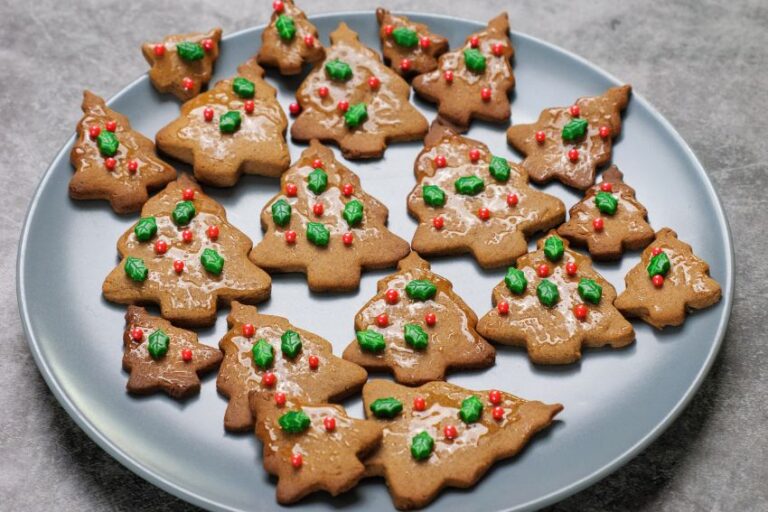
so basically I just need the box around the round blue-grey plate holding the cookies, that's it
[18,12,733,511]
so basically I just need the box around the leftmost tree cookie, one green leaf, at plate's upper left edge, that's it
[69,91,176,213]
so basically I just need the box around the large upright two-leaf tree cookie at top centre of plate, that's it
[291,23,427,158]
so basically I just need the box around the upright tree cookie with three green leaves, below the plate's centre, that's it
[344,252,496,385]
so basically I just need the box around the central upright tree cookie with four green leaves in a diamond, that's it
[251,140,409,292]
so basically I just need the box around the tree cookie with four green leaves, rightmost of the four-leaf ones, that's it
[477,230,635,364]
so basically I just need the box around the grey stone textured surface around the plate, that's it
[0,0,768,512]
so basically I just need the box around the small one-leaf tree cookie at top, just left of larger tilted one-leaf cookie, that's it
[376,7,448,78]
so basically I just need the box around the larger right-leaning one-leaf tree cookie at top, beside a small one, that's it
[413,12,515,130]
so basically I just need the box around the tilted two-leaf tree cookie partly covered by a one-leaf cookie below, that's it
[216,302,368,432]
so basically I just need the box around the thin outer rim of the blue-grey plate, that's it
[16,9,735,512]
